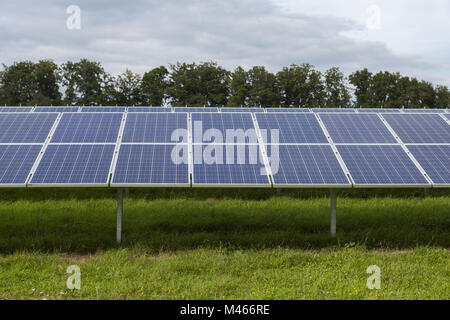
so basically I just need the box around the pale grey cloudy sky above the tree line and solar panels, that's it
[0,0,450,86]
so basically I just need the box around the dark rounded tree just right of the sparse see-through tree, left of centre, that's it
[141,66,169,106]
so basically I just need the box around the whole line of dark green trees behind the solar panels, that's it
[0,59,450,109]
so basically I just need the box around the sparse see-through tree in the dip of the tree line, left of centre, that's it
[115,69,143,106]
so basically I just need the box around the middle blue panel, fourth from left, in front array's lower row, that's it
[193,145,270,187]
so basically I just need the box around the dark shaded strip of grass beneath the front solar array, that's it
[0,197,450,254]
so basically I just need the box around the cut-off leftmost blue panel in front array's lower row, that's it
[0,145,42,186]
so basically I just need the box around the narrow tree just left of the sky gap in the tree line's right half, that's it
[325,67,350,108]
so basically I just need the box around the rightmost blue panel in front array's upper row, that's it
[383,114,450,143]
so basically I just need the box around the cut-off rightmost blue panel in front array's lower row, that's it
[408,145,450,185]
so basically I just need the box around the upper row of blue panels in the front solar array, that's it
[0,113,450,144]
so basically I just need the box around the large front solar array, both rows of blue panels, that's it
[0,113,450,187]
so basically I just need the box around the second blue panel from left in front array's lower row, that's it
[30,144,115,185]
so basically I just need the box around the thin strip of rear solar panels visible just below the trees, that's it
[0,107,450,113]
